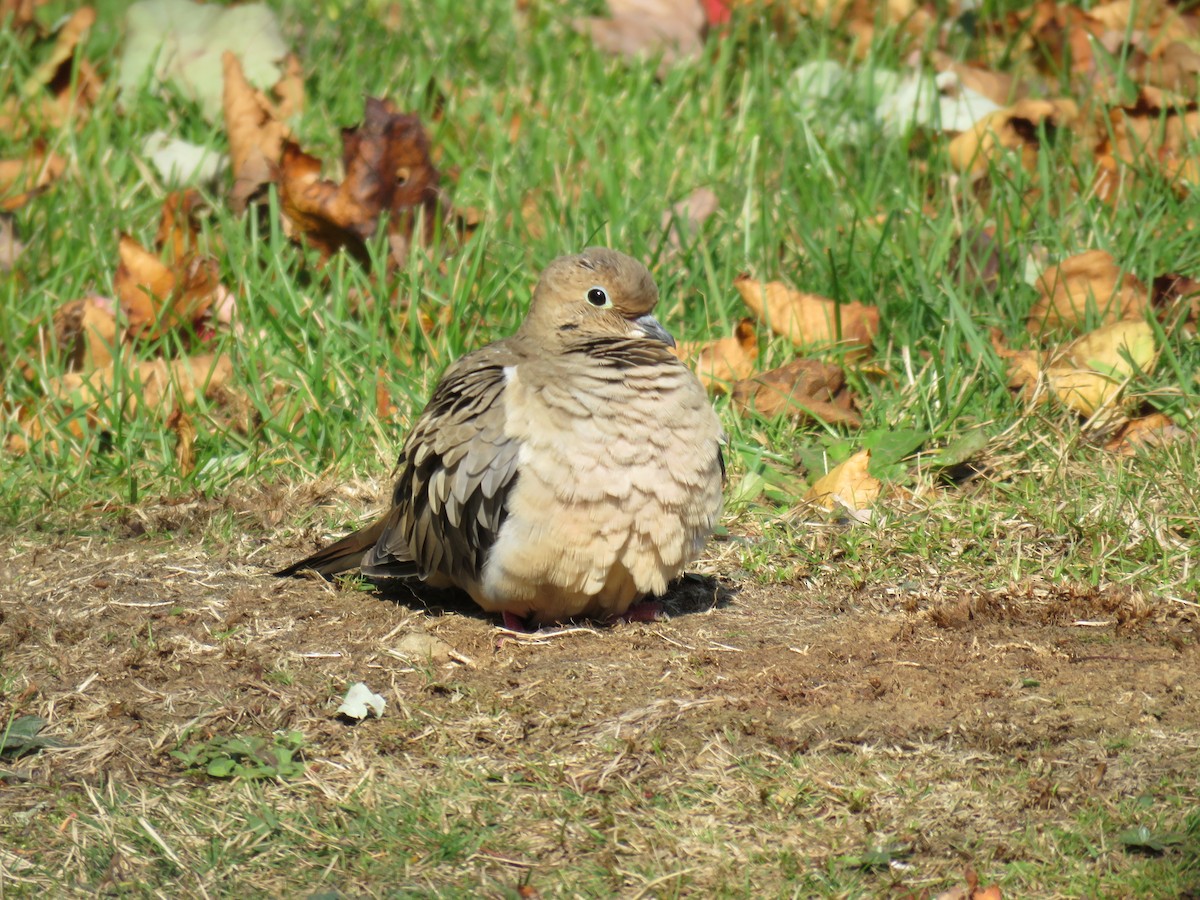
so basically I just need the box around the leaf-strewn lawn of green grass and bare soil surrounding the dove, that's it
[0,0,1200,900]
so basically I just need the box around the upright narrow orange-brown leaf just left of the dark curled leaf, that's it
[221,50,304,214]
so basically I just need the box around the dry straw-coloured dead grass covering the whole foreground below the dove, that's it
[0,486,1200,896]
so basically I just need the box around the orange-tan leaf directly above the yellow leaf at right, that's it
[1027,250,1150,335]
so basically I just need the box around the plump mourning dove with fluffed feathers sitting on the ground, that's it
[277,247,724,624]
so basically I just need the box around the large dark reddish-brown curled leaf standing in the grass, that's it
[280,97,445,264]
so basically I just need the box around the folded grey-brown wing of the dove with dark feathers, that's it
[362,342,520,587]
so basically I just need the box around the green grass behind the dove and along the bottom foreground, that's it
[0,0,1200,896]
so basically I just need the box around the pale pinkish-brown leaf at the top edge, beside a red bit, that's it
[575,0,704,66]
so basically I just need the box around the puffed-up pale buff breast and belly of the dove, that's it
[470,342,721,620]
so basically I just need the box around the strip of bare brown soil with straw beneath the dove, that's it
[0,489,1200,895]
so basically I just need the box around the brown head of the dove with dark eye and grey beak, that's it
[522,247,674,347]
